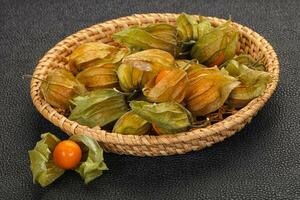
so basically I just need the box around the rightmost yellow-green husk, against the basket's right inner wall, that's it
[222,60,272,108]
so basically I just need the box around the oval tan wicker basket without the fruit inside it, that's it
[31,13,279,156]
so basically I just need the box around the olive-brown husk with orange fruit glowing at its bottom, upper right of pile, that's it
[191,21,239,67]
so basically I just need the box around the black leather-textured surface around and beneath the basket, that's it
[0,0,300,199]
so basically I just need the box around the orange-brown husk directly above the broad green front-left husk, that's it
[76,64,119,90]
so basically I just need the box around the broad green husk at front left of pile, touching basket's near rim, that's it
[69,89,128,128]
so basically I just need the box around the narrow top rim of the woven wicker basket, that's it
[31,13,279,155]
